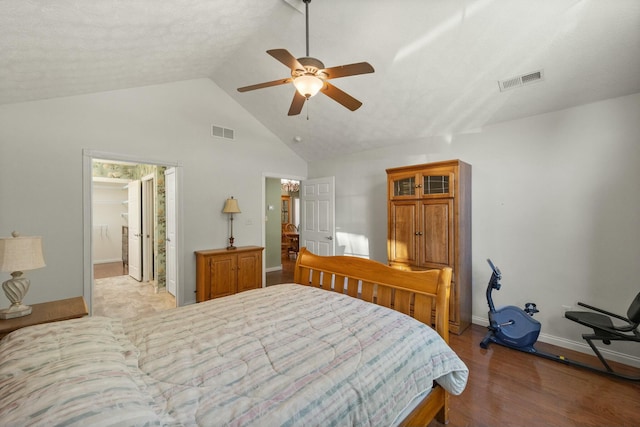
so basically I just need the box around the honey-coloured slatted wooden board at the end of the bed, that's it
[293,248,451,343]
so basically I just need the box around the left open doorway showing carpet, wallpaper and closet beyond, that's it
[83,152,181,318]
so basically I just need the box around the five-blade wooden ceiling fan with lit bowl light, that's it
[238,0,374,116]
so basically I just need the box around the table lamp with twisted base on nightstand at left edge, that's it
[0,231,45,319]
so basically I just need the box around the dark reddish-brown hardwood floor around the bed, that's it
[97,257,640,427]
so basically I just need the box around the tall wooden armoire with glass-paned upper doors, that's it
[387,160,472,334]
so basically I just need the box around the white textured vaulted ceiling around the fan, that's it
[0,0,640,160]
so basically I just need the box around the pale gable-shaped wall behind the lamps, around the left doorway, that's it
[0,79,307,306]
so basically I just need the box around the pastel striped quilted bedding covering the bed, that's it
[0,284,468,427]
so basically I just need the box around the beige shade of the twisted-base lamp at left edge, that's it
[0,233,46,272]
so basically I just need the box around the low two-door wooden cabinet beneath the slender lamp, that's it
[195,246,264,302]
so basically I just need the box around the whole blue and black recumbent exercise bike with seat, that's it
[480,259,640,381]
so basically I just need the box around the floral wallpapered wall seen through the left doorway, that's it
[93,161,167,290]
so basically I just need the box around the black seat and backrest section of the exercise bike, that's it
[564,292,640,380]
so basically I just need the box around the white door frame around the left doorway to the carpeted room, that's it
[82,149,184,315]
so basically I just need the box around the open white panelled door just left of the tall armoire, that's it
[300,176,335,255]
